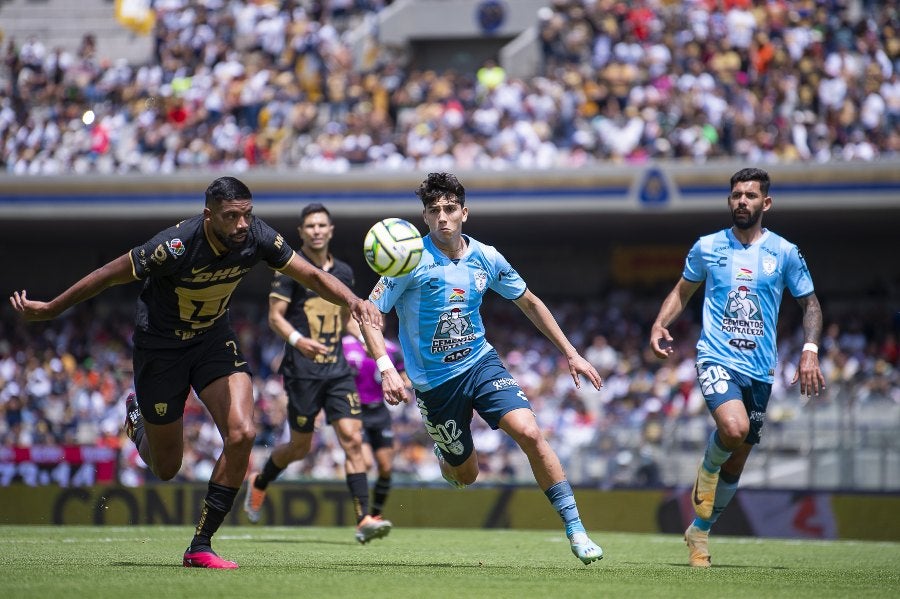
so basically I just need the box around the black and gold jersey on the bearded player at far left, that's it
[129,214,294,349]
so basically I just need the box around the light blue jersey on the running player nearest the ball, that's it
[369,235,526,391]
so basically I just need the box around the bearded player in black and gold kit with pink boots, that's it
[10,177,383,569]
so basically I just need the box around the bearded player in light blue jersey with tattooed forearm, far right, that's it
[650,168,825,568]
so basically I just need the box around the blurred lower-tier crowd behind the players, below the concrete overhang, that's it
[0,290,900,487]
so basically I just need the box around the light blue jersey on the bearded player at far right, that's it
[682,228,815,383]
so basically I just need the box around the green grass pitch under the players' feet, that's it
[0,526,900,599]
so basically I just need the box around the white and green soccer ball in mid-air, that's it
[363,218,423,277]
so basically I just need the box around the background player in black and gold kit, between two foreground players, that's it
[244,204,391,543]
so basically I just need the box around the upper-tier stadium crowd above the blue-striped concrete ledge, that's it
[0,0,900,175]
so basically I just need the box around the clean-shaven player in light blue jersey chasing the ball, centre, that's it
[361,173,603,564]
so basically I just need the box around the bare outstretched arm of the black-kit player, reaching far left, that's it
[9,254,137,321]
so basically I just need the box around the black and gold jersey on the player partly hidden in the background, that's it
[269,251,353,379]
